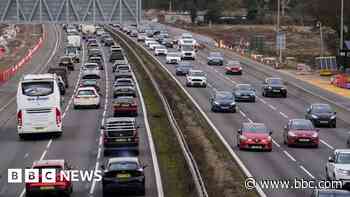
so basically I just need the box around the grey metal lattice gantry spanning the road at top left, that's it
[0,0,142,24]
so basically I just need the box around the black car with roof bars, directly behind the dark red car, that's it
[101,117,139,156]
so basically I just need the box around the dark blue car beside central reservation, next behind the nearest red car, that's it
[209,91,237,113]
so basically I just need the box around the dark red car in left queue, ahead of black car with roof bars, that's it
[113,96,138,117]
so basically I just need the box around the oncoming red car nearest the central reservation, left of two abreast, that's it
[237,123,272,152]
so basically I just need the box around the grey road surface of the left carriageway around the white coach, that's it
[0,25,161,197]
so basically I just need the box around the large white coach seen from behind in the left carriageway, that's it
[17,74,62,138]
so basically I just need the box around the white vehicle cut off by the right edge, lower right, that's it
[326,149,350,187]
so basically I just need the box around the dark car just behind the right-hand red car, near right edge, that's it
[305,103,337,128]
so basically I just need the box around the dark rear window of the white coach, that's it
[22,81,54,96]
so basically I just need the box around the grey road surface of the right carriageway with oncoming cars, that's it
[117,24,350,197]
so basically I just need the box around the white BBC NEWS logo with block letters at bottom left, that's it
[7,168,102,183]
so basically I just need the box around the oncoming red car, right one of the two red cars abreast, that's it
[283,119,320,148]
